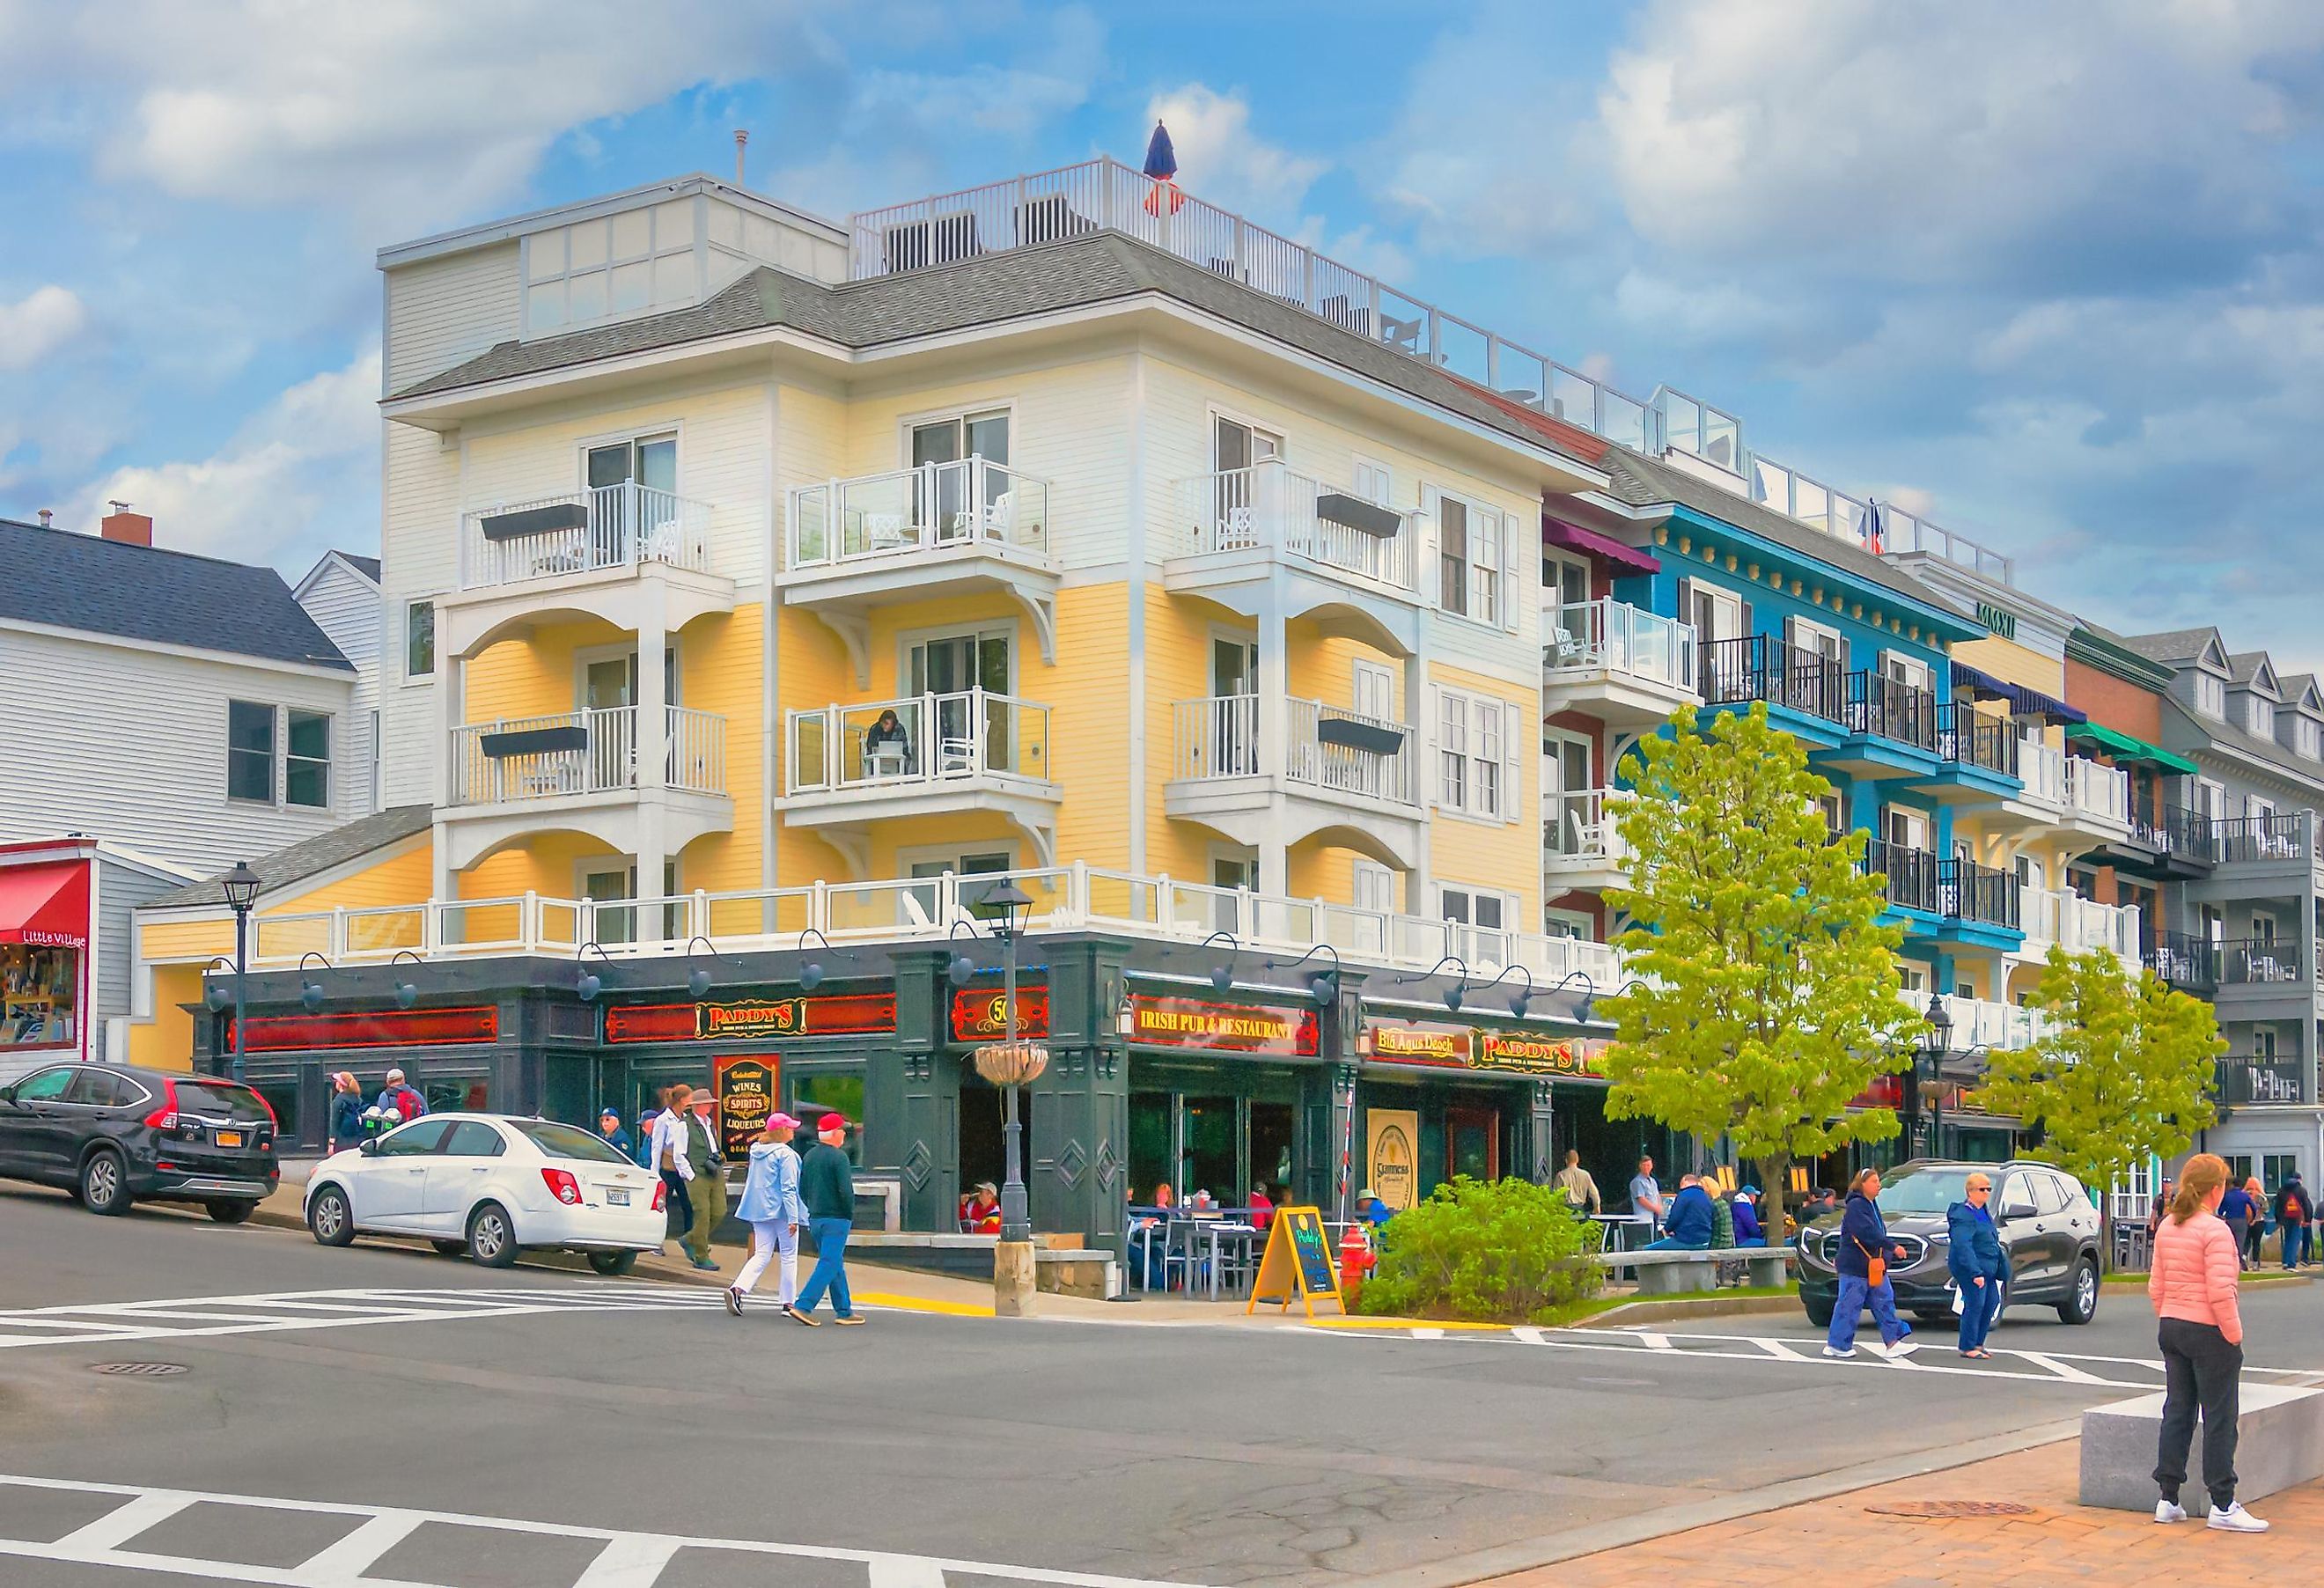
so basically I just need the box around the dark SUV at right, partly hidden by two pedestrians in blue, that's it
[1798,1158,2099,1327]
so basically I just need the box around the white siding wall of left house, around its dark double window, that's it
[0,632,356,874]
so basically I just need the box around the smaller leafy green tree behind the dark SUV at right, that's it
[1978,944,2226,1244]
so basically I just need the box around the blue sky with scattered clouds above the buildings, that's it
[0,0,2324,670]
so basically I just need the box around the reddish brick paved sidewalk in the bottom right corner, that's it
[1489,1439,2324,1588]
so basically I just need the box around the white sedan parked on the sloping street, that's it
[306,1114,667,1274]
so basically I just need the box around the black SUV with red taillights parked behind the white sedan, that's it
[0,1065,281,1223]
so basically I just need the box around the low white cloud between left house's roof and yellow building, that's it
[68,351,379,567]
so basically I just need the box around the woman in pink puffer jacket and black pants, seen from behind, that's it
[2147,1153,2269,1533]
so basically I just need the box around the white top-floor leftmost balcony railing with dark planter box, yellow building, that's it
[460,479,711,591]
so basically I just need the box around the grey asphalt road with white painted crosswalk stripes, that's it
[0,1188,2324,1588]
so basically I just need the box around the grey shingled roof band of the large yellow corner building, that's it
[391,232,1607,474]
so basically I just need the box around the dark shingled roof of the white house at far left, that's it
[0,518,353,672]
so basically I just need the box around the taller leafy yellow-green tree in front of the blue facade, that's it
[1606,704,1920,1237]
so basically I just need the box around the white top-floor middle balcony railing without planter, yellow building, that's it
[788,456,1048,567]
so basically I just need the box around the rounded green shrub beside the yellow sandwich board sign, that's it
[1359,1174,1606,1323]
